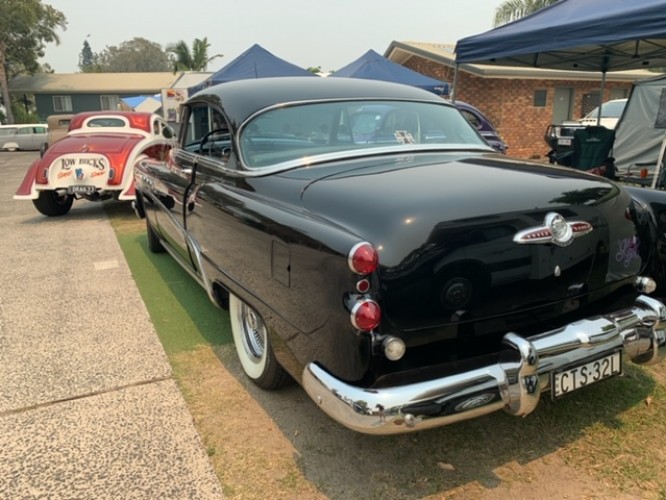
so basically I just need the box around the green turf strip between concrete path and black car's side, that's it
[116,231,232,355]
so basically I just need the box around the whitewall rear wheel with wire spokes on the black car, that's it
[229,295,289,390]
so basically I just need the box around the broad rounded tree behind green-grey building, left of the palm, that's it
[96,37,171,73]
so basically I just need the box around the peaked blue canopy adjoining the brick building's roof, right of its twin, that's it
[331,50,449,95]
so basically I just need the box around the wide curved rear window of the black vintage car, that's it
[240,101,489,168]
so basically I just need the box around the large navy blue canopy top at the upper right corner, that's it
[454,0,666,99]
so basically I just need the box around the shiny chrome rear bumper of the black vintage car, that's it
[303,295,666,434]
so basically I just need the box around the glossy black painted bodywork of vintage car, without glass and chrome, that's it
[137,79,664,386]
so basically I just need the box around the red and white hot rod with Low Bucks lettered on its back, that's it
[14,111,175,217]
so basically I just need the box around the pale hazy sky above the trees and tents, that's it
[41,0,502,73]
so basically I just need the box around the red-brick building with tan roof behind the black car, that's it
[384,41,656,159]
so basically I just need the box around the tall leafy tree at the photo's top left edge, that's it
[0,0,67,123]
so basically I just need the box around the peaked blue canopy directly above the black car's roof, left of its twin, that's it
[188,44,316,95]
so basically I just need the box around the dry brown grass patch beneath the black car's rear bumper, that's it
[174,346,648,499]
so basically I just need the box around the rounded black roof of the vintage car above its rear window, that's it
[188,76,446,123]
